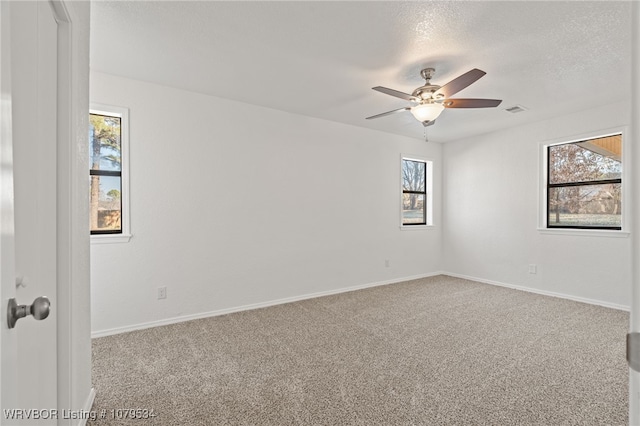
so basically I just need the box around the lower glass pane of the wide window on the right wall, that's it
[548,183,622,227]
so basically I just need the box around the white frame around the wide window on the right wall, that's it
[537,126,630,238]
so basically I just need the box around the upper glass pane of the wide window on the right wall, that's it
[549,135,622,184]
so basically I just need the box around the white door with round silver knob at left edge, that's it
[0,1,58,424]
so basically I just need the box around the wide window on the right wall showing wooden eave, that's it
[546,133,622,230]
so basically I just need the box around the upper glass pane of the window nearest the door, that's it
[89,114,122,171]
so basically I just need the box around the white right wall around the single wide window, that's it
[443,102,631,307]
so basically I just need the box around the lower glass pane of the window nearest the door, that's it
[90,176,122,232]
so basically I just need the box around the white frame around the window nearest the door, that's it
[89,102,132,244]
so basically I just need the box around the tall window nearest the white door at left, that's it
[89,106,129,241]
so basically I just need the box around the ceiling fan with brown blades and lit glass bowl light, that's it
[367,68,502,127]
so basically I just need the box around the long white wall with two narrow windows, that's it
[91,72,442,335]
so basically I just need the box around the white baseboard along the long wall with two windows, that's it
[91,272,441,338]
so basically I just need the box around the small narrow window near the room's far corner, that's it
[401,157,432,227]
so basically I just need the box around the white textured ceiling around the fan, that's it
[91,1,631,142]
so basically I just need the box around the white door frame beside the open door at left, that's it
[49,0,95,424]
